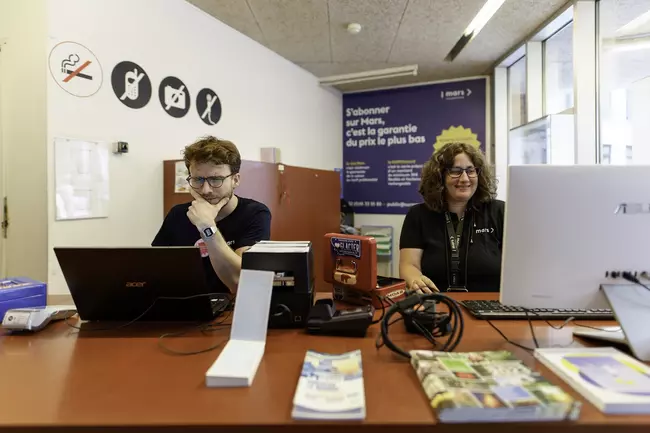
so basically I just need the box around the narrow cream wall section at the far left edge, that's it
[0,0,47,281]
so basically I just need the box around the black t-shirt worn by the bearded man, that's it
[151,196,271,293]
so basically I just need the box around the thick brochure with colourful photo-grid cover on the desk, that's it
[411,350,580,422]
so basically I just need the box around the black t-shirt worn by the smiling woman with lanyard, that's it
[399,200,505,292]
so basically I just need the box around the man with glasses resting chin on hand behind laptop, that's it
[151,136,271,293]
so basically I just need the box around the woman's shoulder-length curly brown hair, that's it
[418,142,497,212]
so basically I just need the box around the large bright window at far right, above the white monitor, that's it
[598,0,650,164]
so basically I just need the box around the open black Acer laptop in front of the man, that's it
[54,247,230,322]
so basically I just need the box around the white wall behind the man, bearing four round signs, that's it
[48,0,342,293]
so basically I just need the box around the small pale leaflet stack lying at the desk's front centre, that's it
[292,350,366,420]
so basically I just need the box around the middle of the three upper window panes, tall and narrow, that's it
[544,22,573,114]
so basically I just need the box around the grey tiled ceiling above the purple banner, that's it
[188,0,567,91]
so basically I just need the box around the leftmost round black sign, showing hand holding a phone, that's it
[111,60,151,108]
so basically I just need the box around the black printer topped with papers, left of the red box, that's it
[242,241,314,328]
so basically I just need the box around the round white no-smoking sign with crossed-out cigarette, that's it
[49,41,104,98]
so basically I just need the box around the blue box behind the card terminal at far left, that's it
[0,277,47,320]
